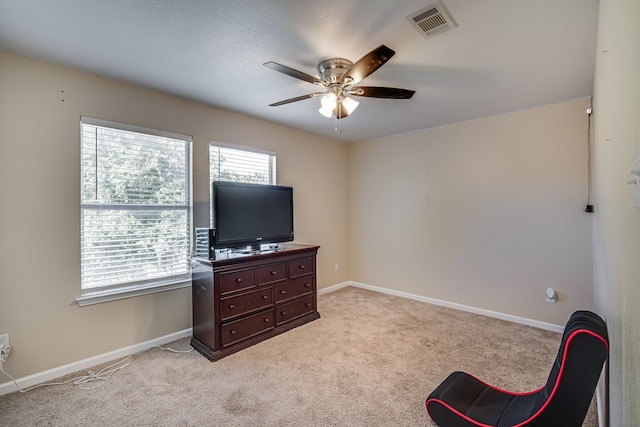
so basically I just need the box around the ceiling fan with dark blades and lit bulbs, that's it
[264,45,415,119]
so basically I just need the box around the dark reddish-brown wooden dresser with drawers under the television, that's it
[191,244,320,361]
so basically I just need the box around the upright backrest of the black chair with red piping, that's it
[529,311,609,427]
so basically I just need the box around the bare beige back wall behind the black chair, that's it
[349,99,592,325]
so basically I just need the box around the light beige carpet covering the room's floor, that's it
[0,287,597,427]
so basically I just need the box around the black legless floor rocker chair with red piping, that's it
[426,311,609,427]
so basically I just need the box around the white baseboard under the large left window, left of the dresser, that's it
[0,328,192,396]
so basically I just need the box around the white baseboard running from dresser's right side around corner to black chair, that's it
[318,281,564,333]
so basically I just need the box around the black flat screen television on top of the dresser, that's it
[211,181,293,250]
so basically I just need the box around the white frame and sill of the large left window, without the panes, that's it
[76,116,193,306]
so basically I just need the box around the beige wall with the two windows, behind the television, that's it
[0,52,348,382]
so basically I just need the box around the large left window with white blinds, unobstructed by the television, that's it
[78,117,192,305]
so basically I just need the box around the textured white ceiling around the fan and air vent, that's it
[0,0,598,142]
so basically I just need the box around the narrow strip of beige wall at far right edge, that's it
[593,0,640,426]
